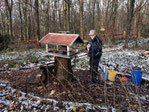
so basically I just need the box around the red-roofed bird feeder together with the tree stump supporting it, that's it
[39,33,83,82]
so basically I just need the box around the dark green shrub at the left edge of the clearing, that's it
[0,34,10,50]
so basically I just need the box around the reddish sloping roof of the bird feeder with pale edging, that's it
[39,33,83,46]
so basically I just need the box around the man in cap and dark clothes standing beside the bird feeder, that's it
[87,30,103,83]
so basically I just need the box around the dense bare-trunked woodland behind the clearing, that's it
[0,0,149,47]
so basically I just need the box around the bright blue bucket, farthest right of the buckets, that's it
[131,69,142,85]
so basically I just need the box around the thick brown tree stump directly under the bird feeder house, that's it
[54,57,74,82]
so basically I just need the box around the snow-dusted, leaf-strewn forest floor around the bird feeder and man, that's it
[0,39,149,112]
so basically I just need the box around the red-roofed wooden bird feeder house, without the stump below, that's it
[39,33,83,58]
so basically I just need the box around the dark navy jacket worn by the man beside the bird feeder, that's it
[88,35,103,58]
